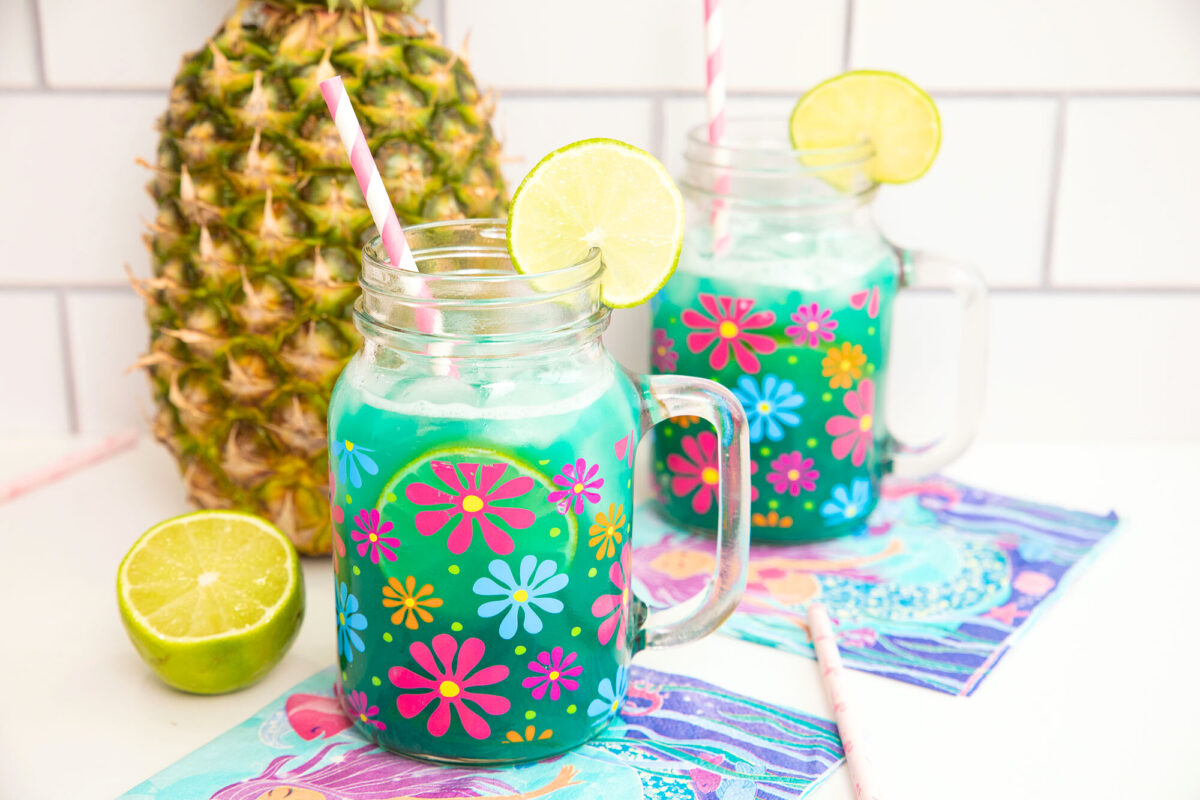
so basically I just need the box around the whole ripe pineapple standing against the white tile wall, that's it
[133,0,505,554]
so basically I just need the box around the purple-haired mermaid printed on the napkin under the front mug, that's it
[211,744,578,800]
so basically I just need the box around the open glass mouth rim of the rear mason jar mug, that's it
[684,116,875,174]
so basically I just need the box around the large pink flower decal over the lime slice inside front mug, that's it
[404,461,535,555]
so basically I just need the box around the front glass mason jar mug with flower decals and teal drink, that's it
[329,219,749,763]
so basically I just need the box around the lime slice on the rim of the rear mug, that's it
[791,70,942,184]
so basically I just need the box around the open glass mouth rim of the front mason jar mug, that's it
[360,218,604,305]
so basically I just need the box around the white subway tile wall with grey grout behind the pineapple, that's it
[0,0,1200,441]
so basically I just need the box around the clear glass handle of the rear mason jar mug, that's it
[888,251,988,476]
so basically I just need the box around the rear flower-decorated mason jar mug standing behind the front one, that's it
[650,120,986,541]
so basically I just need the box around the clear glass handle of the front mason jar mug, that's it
[640,375,750,648]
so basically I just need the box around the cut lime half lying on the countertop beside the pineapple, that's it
[116,511,304,694]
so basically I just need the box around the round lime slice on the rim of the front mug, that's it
[509,139,683,308]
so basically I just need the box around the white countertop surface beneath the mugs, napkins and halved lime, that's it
[0,439,1200,800]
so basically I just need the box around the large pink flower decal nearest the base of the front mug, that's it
[388,633,510,739]
